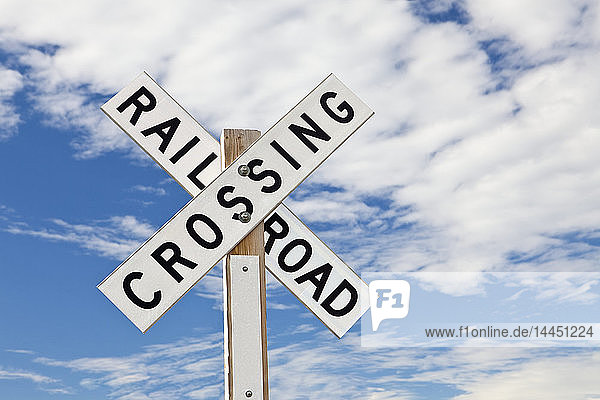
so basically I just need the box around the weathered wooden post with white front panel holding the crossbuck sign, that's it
[221,129,269,400]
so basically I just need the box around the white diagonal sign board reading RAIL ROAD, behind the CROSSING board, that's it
[102,72,372,338]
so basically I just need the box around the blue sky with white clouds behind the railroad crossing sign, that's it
[0,0,600,400]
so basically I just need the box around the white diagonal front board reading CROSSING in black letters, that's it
[99,75,373,332]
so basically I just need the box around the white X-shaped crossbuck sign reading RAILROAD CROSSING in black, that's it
[98,72,373,337]
